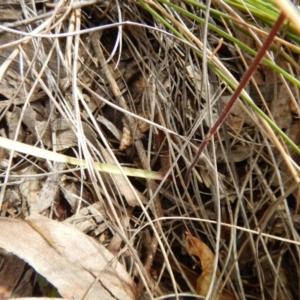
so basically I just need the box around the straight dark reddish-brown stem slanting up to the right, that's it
[184,12,285,184]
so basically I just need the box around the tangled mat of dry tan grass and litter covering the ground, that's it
[0,1,300,299]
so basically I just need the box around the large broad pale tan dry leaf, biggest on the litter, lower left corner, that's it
[0,213,136,300]
